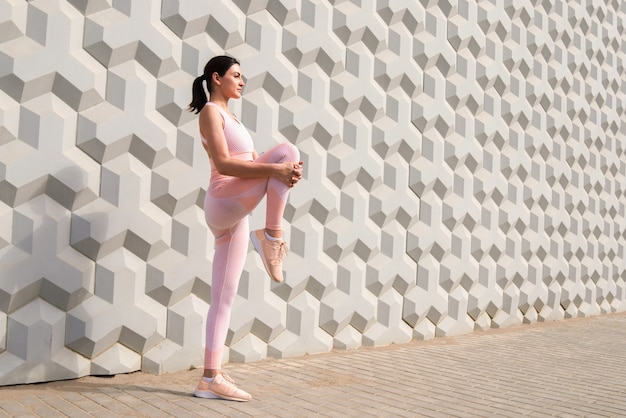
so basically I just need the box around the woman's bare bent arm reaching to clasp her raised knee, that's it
[199,106,302,185]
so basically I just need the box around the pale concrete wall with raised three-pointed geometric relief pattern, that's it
[0,0,626,384]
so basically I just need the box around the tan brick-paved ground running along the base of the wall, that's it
[0,313,626,418]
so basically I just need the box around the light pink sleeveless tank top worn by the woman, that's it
[200,102,254,190]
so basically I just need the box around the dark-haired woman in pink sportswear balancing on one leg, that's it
[189,55,302,401]
